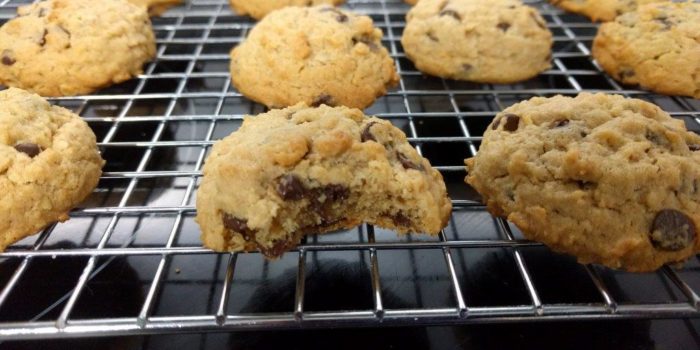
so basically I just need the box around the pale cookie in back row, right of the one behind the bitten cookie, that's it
[401,0,552,84]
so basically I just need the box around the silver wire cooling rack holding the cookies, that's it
[0,0,700,340]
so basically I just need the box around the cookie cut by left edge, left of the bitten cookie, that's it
[0,88,104,251]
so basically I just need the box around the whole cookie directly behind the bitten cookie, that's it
[231,6,399,108]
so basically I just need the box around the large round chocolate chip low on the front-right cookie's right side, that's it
[651,209,695,251]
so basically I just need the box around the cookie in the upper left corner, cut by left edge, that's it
[0,0,155,96]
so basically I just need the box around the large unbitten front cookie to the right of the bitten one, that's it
[466,93,700,272]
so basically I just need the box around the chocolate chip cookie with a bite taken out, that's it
[197,104,451,257]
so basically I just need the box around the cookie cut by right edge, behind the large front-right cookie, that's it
[593,2,700,98]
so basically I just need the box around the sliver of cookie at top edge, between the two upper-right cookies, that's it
[549,0,668,22]
